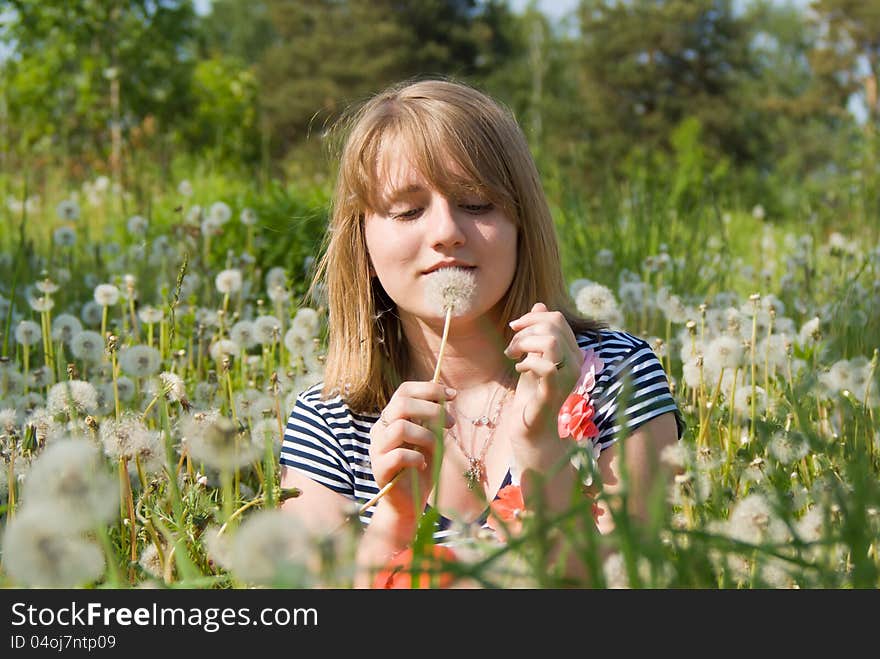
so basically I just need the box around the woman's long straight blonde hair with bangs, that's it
[311,79,600,413]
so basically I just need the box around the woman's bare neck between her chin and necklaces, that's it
[401,316,513,390]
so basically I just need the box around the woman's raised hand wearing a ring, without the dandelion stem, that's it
[504,302,583,439]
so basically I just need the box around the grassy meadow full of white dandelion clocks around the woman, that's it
[0,148,880,588]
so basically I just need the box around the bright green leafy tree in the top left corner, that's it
[2,0,195,180]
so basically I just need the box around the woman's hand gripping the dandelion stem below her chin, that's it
[370,382,455,519]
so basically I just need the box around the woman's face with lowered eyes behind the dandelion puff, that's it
[364,153,517,322]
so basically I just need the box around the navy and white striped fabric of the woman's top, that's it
[281,330,684,541]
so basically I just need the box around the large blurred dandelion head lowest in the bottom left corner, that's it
[3,502,104,588]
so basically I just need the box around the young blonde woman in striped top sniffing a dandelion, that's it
[281,80,681,585]
